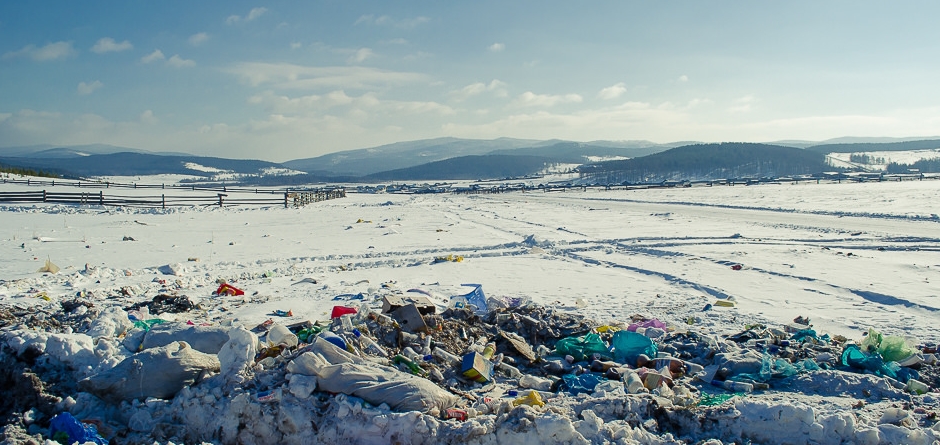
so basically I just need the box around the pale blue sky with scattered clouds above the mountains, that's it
[0,0,940,161]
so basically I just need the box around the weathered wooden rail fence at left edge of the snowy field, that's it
[0,188,346,209]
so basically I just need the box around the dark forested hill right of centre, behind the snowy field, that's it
[580,143,831,183]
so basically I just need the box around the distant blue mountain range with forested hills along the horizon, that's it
[0,138,940,184]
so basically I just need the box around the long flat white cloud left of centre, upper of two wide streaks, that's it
[227,62,427,90]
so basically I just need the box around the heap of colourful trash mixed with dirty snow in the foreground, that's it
[0,283,940,443]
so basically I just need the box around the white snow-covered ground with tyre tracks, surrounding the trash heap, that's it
[0,175,940,444]
